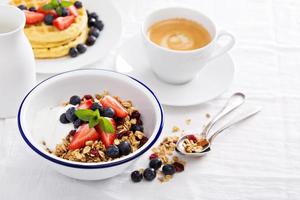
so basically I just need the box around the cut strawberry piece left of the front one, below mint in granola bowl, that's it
[69,124,100,150]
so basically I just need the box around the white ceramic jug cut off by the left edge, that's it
[0,5,35,118]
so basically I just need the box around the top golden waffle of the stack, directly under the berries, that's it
[11,0,88,46]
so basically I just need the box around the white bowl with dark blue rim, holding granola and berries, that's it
[18,69,164,180]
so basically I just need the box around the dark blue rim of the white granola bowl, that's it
[18,69,164,169]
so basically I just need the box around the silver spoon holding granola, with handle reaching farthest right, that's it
[176,108,261,157]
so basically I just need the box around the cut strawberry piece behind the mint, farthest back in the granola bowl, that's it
[100,95,128,118]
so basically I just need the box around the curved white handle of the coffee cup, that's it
[208,30,235,61]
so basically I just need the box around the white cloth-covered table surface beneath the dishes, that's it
[0,0,300,200]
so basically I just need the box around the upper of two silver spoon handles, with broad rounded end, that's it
[201,92,246,138]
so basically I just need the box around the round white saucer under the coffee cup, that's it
[115,35,234,106]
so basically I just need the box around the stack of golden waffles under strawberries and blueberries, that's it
[10,0,88,59]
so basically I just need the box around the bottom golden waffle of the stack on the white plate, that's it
[33,28,89,59]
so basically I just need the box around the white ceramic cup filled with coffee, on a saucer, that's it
[142,7,235,84]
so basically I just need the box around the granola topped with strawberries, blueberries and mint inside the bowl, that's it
[47,91,148,163]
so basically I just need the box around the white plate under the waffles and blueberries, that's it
[28,0,122,74]
